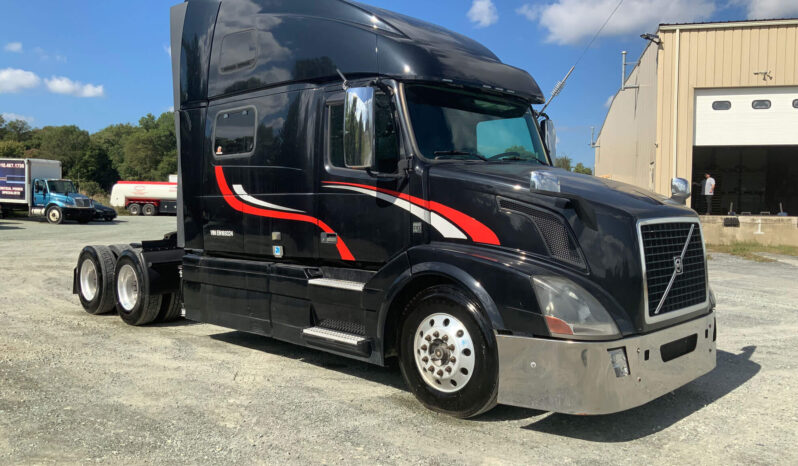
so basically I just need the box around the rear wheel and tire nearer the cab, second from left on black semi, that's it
[114,251,162,325]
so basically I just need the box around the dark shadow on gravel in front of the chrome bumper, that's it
[524,346,762,442]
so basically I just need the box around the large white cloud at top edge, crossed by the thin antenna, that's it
[516,0,720,45]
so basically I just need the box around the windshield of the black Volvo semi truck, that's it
[405,85,549,165]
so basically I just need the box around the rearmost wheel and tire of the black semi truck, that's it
[76,246,116,315]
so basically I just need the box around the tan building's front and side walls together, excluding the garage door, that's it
[596,20,798,195]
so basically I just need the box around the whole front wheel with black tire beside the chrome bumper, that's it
[399,285,499,418]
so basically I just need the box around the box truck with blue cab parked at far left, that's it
[0,159,95,224]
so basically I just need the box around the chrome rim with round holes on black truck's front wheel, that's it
[413,313,476,393]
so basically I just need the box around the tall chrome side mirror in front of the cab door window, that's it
[344,87,375,168]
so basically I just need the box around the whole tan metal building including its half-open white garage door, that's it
[596,19,798,215]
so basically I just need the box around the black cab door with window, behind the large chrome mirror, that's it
[318,91,410,268]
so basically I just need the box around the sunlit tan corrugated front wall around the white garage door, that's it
[655,20,798,195]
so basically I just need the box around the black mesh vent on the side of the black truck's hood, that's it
[499,198,586,269]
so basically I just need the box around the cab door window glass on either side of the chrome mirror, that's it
[328,94,399,173]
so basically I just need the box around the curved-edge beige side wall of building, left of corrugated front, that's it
[595,45,657,189]
